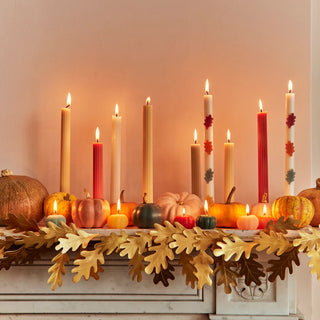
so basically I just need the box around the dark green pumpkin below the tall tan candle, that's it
[132,194,164,229]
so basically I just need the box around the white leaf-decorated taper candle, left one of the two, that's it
[203,79,214,200]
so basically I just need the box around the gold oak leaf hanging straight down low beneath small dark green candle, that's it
[192,251,213,290]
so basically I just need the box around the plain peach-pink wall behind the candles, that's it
[0,0,320,319]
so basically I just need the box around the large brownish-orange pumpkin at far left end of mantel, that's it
[0,170,48,221]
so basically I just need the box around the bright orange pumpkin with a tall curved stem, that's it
[209,187,246,228]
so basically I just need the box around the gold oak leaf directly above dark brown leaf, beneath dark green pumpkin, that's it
[144,242,174,274]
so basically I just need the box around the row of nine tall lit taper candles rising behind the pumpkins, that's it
[60,80,295,210]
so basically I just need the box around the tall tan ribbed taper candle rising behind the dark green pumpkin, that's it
[142,97,153,203]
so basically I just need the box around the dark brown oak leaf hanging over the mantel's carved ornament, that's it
[238,253,265,286]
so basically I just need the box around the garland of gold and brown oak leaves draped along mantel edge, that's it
[0,215,320,294]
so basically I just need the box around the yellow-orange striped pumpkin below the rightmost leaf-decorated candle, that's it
[272,196,314,228]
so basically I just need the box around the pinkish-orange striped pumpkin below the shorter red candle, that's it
[71,191,110,228]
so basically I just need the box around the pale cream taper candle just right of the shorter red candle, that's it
[110,105,121,203]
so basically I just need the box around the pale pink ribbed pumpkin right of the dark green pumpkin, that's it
[156,192,204,223]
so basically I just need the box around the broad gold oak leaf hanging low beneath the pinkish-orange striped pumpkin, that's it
[71,249,104,283]
